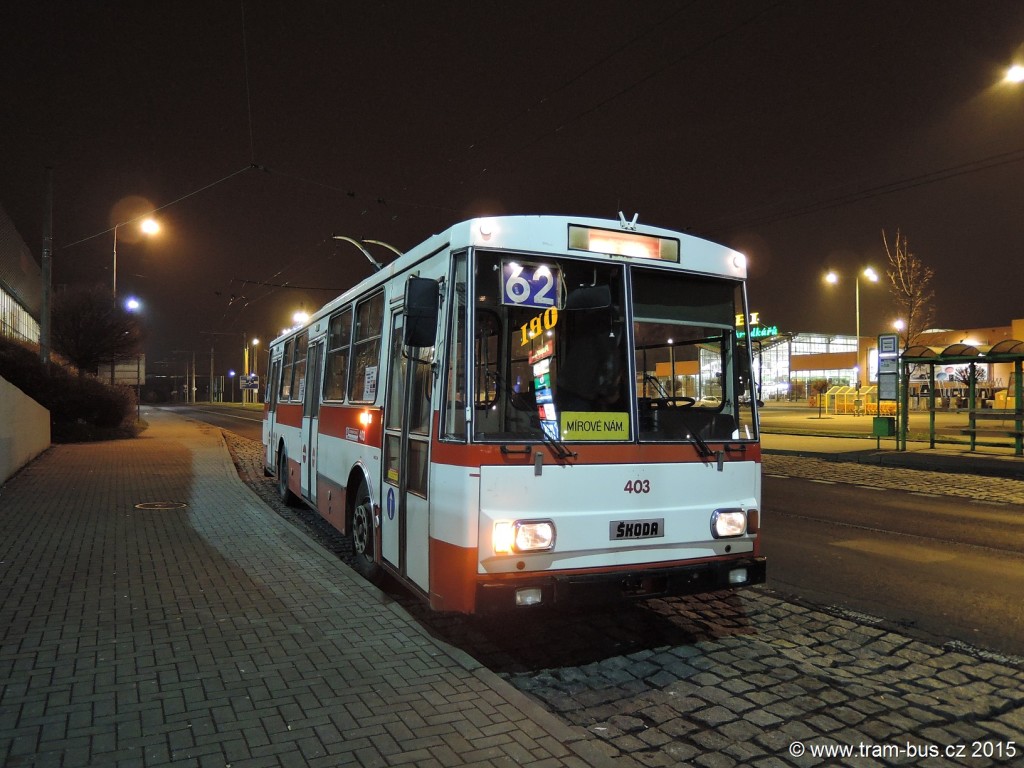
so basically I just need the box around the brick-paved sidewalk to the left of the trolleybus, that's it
[0,411,605,768]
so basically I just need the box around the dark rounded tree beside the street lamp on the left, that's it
[50,287,143,376]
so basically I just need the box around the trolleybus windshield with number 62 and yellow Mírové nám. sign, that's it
[460,251,756,451]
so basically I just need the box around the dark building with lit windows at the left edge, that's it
[0,206,43,344]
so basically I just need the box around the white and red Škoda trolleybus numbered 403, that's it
[263,215,765,613]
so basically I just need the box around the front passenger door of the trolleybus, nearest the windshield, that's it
[381,306,434,591]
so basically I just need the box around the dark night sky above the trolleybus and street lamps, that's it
[0,0,1024,373]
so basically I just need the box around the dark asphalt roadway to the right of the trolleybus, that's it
[763,479,1024,655]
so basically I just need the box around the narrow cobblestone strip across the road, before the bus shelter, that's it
[762,454,1024,504]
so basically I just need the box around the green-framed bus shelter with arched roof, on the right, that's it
[901,339,1024,456]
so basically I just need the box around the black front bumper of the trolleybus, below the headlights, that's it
[476,556,766,613]
